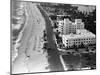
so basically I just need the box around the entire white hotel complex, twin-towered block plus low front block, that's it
[58,19,96,47]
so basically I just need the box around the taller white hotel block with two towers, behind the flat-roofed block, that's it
[58,19,84,35]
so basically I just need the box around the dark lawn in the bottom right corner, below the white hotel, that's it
[62,53,96,70]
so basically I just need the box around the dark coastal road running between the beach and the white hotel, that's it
[37,5,64,71]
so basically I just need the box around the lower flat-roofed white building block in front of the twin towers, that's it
[62,29,96,48]
